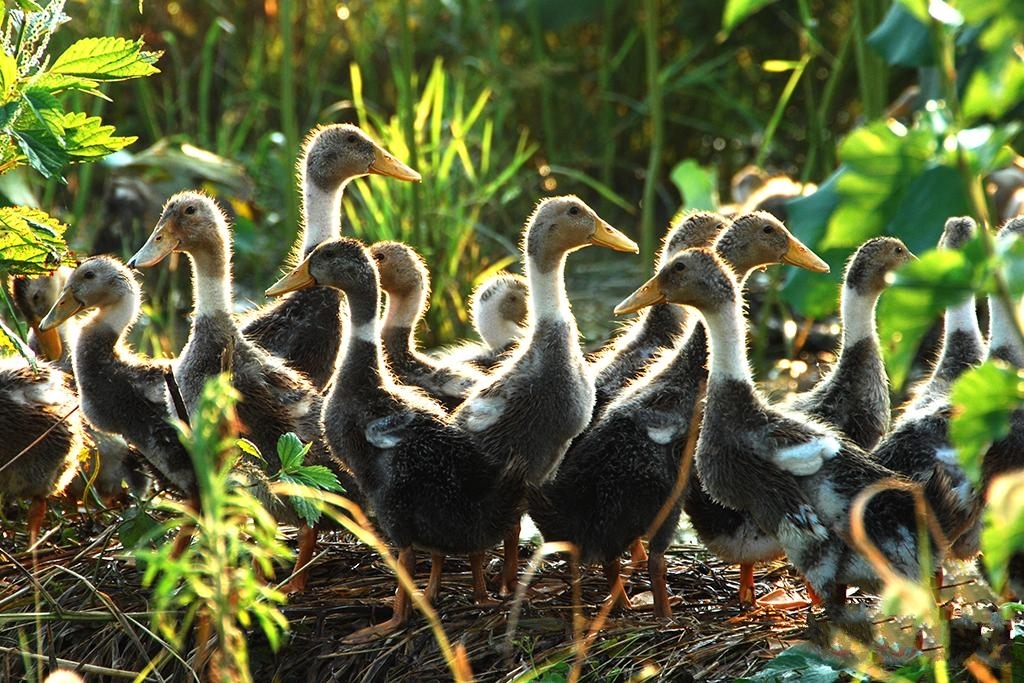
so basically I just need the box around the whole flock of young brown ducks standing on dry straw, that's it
[0,125,1024,642]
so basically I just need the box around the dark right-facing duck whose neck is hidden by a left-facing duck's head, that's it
[528,214,828,617]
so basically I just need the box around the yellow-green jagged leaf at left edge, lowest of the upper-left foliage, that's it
[0,206,68,275]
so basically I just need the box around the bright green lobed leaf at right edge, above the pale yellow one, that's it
[949,360,1024,482]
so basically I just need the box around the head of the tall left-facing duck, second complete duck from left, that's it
[128,190,229,268]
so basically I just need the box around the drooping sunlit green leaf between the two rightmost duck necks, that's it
[876,251,980,389]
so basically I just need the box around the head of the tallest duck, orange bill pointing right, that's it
[301,123,422,190]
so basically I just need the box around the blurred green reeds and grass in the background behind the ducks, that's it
[0,0,1024,362]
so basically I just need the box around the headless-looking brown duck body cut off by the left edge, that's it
[0,357,82,547]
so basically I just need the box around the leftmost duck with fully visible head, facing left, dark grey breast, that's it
[40,256,197,497]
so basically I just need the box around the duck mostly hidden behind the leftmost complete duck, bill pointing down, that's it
[11,266,151,507]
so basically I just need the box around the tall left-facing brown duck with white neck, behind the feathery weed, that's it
[128,190,360,592]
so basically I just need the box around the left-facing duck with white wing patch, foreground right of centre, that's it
[616,248,947,638]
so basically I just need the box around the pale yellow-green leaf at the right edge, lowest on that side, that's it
[981,472,1024,592]
